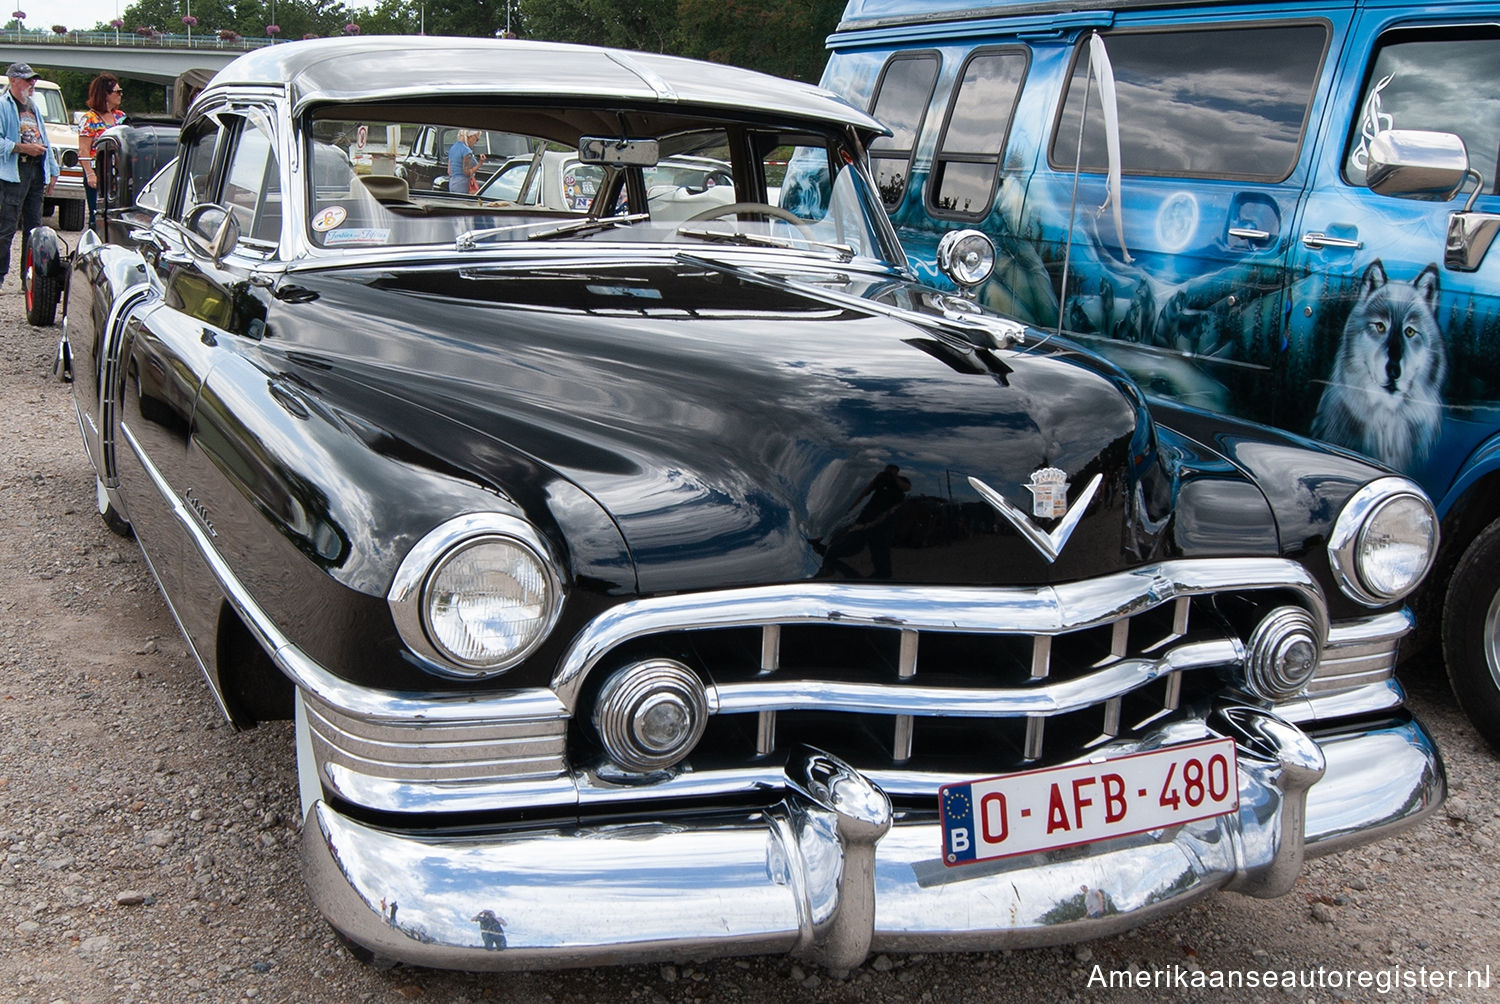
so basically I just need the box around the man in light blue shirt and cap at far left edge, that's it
[0,63,57,289]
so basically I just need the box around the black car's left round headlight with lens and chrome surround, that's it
[389,513,563,678]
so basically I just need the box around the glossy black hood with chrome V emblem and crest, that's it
[269,260,1170,593]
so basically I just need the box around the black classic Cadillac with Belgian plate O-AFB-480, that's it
[35,38,1445,969]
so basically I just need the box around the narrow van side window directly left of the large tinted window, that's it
[929,48,1031,219]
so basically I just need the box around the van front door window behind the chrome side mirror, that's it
[1344,29,1500,192]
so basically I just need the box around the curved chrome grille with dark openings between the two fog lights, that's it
[554,558,1328,774]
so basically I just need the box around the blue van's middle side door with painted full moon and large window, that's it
[1022,5,1352,420]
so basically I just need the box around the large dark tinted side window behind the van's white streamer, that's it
[1049,24,1328,182]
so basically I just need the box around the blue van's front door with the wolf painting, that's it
[1280,3,1500,500]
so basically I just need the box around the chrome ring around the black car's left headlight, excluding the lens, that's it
[386,513,564,680]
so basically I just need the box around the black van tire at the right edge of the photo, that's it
[1443,521,1500,752]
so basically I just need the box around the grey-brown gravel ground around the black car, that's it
[0,226,1500,1004]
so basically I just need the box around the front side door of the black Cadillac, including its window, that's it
[122,108,282,699]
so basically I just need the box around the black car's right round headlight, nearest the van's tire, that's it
[1328,477,1439,606]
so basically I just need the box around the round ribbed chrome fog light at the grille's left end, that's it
[594,659,708,771]
